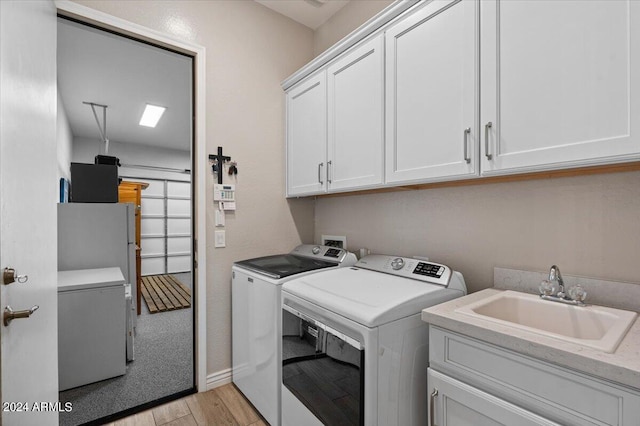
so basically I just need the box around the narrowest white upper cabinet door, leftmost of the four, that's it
[287,71,327,196]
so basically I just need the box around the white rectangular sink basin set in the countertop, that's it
[456,290,637,353]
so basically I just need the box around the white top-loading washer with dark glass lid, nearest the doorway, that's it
[231,245,356,425]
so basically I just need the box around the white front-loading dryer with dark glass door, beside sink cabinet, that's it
[281,255,467,426]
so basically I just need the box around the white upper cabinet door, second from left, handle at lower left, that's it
[327,35,384,191]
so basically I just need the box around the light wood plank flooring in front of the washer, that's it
[106,383,267,426]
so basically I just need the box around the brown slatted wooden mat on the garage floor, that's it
[142,275,191,314]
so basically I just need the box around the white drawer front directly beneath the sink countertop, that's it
[429,326,640,425]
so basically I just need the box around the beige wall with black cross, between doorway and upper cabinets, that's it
[70,0,313,382]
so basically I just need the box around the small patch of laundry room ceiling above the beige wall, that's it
[255,0,349,31]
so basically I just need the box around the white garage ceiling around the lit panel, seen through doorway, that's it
[58,18,192,150]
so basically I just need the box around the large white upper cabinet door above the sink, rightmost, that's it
[481,0,640,174]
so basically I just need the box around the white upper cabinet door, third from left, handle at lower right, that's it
[385,0,478,183]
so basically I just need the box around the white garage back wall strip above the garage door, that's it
[73,137,191,181]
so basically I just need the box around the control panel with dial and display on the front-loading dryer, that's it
[355,254,452,286]
